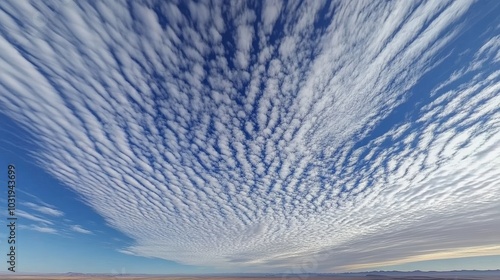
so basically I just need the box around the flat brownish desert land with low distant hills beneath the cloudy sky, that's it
[0,270,500,280]
